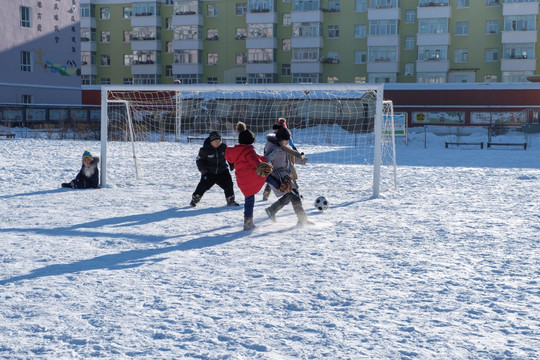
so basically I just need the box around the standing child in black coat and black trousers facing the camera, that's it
[189,131,240,207]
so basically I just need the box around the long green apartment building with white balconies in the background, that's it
[80,0,538,85]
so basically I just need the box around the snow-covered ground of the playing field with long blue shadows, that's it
[0,133,540,360]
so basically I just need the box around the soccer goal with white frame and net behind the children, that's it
[101,84,396,196]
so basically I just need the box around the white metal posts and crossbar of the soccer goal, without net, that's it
[101,84,396,197]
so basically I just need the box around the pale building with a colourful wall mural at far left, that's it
[0,0,81,104]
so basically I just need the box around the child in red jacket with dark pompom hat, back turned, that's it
[225,122,271,230]
